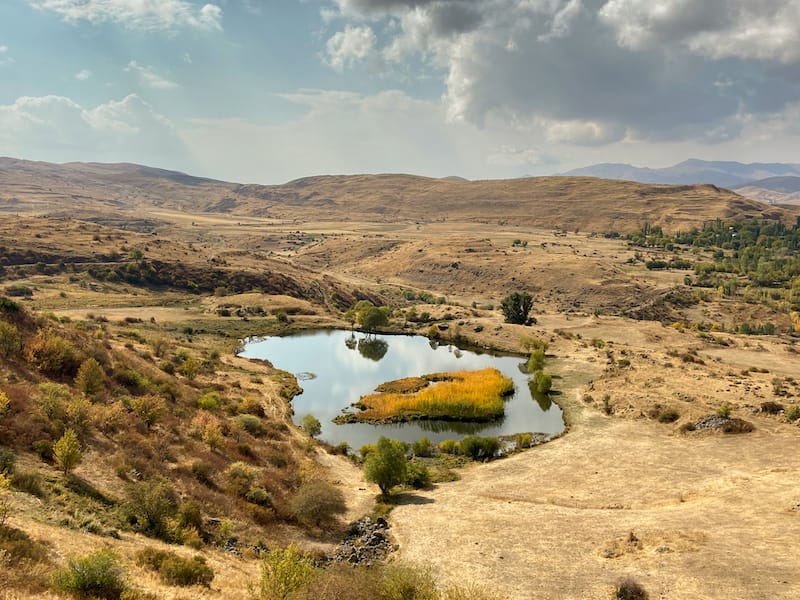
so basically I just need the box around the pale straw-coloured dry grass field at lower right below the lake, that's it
[392,390,800,600]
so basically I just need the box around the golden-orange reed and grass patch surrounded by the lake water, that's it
[335,368,514,423]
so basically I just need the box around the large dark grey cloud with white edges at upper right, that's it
[320,0,800,160]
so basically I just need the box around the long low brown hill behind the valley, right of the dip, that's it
[231,175,784,232]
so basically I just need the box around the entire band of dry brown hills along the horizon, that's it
[0,158,794,232]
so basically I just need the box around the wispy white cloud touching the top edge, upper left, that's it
[28,0,222,30]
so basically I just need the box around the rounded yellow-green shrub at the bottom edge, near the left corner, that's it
[53,550,127,600]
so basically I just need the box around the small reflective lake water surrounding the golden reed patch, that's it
[240,330,564,450]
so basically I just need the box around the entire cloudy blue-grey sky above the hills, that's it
[0,0,800,184]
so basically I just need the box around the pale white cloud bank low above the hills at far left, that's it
[0,95,189,168]
